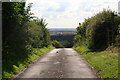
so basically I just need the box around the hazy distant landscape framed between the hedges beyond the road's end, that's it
[49,28,76,47]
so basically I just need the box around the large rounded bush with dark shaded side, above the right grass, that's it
[74,10,120,51]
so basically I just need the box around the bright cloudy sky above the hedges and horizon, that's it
[27,0,120,28]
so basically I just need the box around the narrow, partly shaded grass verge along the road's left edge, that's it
[2,46,54,80]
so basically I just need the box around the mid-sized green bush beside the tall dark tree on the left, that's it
[28,19,50,48]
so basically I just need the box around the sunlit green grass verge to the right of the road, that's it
[74,46,118,78]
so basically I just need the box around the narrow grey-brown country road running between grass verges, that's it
[16,48,97,78]
